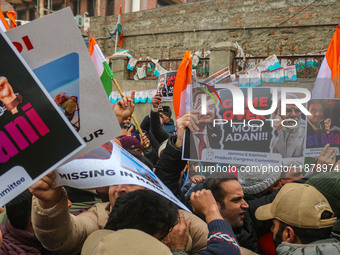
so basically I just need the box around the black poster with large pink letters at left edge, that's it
[0,29,85,206]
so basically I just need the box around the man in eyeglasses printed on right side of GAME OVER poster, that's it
[271,94,306,166]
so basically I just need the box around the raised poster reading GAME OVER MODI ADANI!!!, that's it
[183,85,306,167]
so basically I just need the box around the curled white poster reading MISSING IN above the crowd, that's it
[56,143,189,211]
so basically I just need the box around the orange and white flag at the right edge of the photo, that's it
[312,25,340,98]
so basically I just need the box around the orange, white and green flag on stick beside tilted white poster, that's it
[89,37,114,97]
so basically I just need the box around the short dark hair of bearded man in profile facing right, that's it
[204,173,237,209]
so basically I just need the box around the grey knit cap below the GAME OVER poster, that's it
[238,168,281,195]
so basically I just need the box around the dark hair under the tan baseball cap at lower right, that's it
[278,211,334,244]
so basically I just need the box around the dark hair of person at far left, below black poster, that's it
[6,190,32,229]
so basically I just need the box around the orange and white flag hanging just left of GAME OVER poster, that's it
[173,51,192,118]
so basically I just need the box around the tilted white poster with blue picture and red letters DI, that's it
[6,8,121,156]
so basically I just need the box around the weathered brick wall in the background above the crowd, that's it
[90,0,340,123]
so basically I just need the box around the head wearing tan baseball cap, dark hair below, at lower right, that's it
[255,183,336,244]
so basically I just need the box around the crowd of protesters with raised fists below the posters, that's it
[0,92,340,255]
